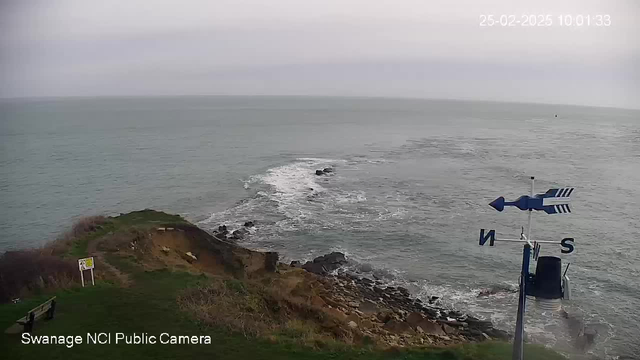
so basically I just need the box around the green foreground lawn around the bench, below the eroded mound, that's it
[0,262,563,360]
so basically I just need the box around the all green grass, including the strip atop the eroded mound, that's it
[0,211,564,360]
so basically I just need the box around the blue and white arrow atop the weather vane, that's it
[489,188,574,214]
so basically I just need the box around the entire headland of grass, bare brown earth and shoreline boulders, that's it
[0,210,564,359]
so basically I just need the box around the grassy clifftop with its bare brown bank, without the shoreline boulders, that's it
[0,210,562,360]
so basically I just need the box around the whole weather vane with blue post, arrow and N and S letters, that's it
[479,176,574,360]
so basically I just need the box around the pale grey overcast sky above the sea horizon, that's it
[0,0,640,108]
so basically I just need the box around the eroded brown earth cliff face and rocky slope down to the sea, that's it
[97,214,508,346]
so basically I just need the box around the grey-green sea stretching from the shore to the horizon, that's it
[0,96,640,359]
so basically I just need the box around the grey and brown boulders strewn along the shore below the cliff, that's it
[289,252,510,346]
